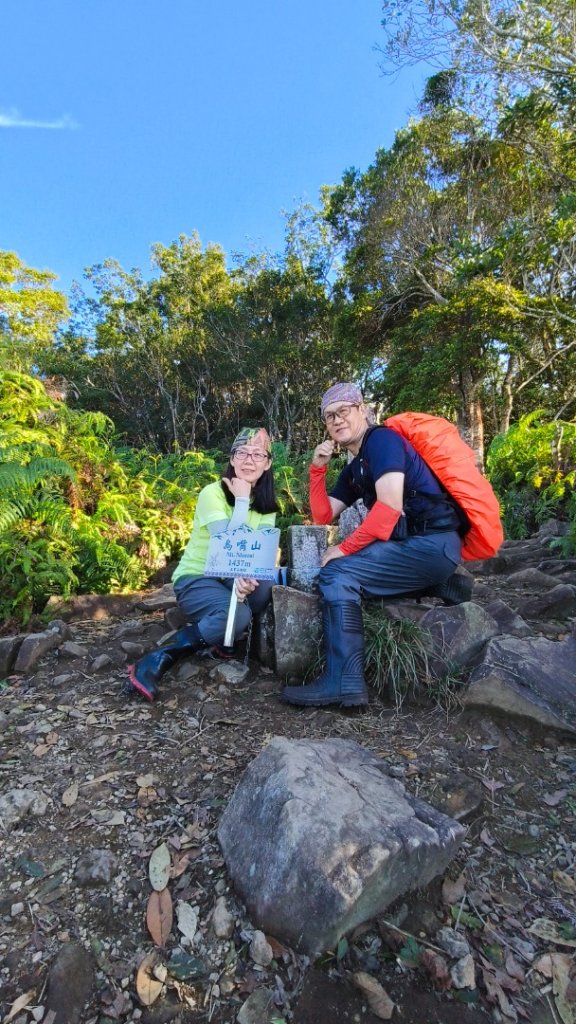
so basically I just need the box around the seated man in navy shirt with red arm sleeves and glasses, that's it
[282,383,461,707]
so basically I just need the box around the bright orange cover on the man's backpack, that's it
[384,413,504,561]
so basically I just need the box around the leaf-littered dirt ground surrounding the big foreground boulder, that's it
[0,614,576,1024]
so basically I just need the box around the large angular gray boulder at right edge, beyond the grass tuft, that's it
[463,633,576,733]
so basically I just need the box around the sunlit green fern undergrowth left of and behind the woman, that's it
[0,371,305,629]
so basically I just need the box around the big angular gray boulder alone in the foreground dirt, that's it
[218,737,464,956]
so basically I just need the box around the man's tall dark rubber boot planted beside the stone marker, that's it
[281,601,368,708]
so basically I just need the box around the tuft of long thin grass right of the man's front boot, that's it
[363,608,461,712]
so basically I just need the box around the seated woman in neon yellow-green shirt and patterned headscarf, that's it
[128,427,278,700]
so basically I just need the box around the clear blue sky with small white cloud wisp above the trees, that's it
[0,0,429,290]
